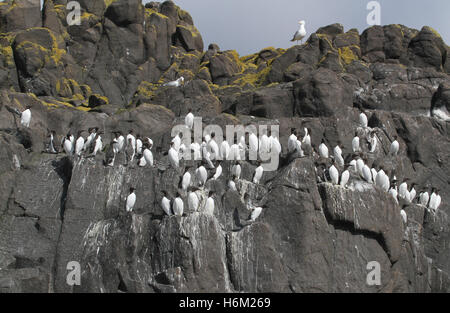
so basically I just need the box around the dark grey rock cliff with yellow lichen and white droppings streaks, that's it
[0,0,450,292]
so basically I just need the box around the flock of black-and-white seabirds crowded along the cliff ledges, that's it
[7,92,441,223]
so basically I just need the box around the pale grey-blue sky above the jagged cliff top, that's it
[143,0,450,56]
